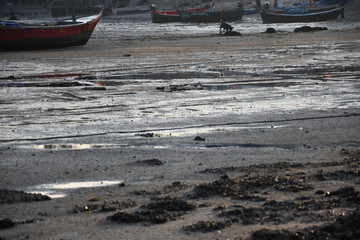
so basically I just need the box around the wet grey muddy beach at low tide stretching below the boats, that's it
[0,2,360,239]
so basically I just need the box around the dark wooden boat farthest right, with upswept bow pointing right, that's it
[260,6,345,23]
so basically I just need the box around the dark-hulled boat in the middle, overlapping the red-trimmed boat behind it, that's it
[180,8,243,22]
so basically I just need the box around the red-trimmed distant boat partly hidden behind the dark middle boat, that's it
[151,6,210,23]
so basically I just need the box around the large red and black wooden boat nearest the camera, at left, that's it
[0,12,102,50]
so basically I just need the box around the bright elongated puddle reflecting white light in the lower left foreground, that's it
[26,181,123,198]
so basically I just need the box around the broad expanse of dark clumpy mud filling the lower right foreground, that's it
[103,149,360,240]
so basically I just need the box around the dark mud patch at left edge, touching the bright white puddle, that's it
[0,189,51,204]
